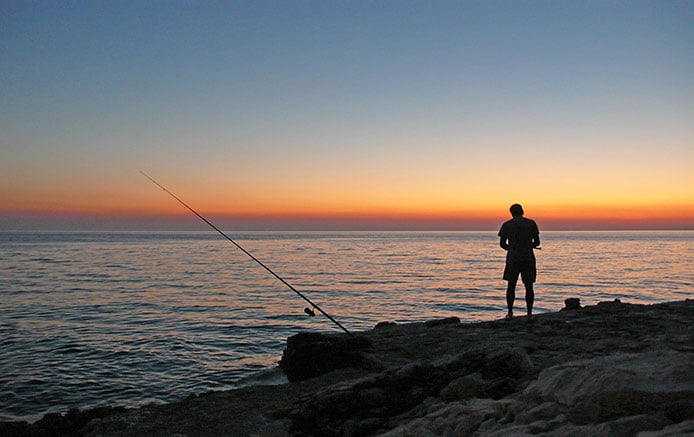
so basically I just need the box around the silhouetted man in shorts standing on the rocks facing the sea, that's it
[499,203,540,320]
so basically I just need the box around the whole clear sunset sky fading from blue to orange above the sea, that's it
[0,0,694,230]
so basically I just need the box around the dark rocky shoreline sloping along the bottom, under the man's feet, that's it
[0,299,694,436]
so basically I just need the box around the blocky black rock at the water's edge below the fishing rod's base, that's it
[279,332,370,381]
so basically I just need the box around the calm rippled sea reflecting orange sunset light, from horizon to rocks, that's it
[0,230,694,421]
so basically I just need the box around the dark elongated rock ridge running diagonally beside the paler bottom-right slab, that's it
[290,347,544,436]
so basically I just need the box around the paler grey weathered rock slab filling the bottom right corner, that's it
[383,350,694,437]
